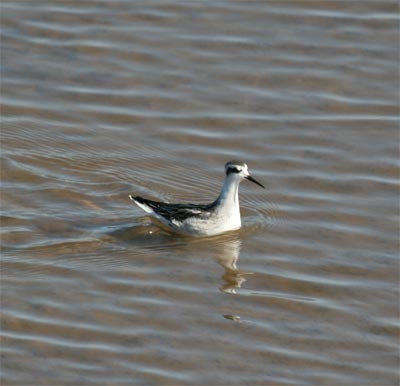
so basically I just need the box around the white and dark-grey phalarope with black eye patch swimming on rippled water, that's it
[129,161,265,236]
